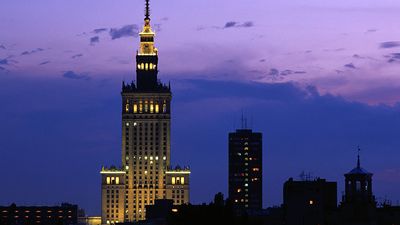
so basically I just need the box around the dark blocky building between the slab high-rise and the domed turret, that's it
[283,178,337,225]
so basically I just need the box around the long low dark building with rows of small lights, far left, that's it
[0,203,78,225]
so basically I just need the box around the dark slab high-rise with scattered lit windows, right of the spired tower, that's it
[229,129,262,213]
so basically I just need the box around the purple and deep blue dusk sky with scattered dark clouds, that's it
[0,0,400,215]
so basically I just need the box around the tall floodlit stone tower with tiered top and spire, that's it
[101,0,190,224]
